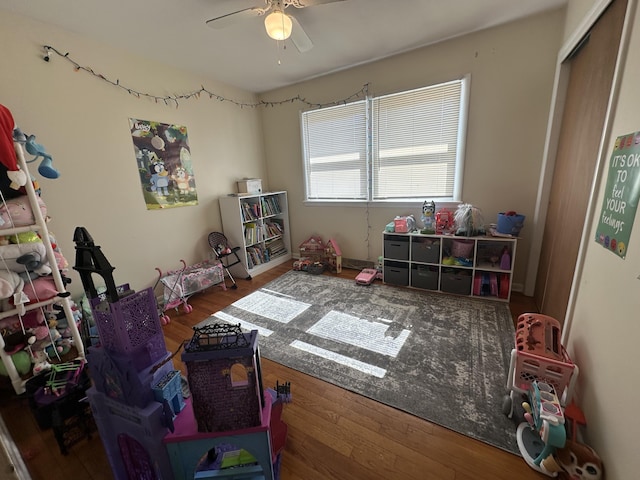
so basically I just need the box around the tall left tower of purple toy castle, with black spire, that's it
[74,227,174,479]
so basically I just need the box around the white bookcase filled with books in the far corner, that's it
[220,192,291,276]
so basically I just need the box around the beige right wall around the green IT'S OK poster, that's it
[566,0,640,480]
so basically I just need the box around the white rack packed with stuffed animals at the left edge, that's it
[0,105,84,394]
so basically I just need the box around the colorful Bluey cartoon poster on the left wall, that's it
[129,118,198,210]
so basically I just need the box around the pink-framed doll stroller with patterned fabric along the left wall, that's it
[154,260,227,325]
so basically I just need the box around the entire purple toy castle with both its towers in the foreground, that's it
[74,228,290,480]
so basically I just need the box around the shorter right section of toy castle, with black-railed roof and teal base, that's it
[164,324,290,480]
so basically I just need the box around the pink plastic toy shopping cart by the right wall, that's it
[502,313,578,418]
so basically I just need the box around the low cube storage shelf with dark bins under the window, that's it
[383,232,518,302]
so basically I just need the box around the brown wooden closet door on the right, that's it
[534,0,627,323]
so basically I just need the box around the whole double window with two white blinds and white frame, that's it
[301,77,469,202]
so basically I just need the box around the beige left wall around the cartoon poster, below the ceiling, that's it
[0,12,266,294]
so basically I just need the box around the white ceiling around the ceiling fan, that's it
[0,0,567,93]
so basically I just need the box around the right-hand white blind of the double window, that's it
[372,81,462,200]
